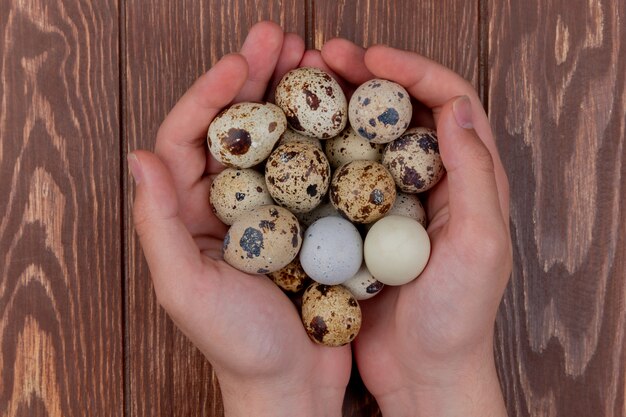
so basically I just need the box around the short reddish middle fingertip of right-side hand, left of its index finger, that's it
[321,38,375,85]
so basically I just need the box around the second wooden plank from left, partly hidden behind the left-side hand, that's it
[124,0,305,416]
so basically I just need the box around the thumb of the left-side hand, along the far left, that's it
[128,151,202,311]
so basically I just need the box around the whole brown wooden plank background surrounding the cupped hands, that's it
[0,0,626,417]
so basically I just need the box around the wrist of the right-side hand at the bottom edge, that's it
[376,342,507,417]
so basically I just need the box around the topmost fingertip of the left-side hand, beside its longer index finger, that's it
[234,22,284,102]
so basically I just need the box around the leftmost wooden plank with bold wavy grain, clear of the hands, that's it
[0,0,123,417]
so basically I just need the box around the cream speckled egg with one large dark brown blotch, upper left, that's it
[208,103,287,168]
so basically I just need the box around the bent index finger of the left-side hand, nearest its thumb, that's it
[155,54,248,194]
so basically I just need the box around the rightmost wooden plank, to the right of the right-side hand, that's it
[489,0,626,417]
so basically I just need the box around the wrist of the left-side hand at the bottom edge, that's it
[219,378,345,417]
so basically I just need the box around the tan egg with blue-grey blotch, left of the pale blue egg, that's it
[223,205,302,274]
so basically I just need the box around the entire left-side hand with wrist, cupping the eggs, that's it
[129,22,351,416]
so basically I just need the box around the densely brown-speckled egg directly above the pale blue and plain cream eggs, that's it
[329,161,396,223]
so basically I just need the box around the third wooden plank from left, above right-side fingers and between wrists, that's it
[313,0,479,416]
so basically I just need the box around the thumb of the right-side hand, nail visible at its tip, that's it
[437,96,503,222]
